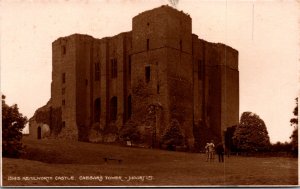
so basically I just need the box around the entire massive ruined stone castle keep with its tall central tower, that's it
[30,6,239,149]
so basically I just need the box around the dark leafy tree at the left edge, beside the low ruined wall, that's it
[2,95,27,157]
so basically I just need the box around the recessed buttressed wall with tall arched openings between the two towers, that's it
[72,32,131,142]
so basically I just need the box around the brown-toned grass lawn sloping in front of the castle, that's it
[2,138,298,186]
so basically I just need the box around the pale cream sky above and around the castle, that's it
[0,0,300,143]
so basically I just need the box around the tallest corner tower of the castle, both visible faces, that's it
[132,6,194,147]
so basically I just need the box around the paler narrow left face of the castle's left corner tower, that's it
[51,34,79,140]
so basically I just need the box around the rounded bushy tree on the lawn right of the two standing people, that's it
[233,112,270,152]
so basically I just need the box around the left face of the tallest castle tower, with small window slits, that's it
[131,6,169,146]
